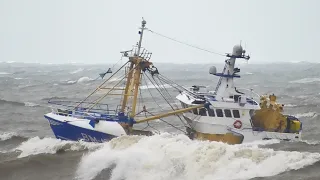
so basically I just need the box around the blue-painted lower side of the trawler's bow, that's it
[44,116,117,143]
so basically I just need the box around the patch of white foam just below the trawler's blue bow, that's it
[14,137,102,158]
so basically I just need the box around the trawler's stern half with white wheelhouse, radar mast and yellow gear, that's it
[176,45,302,144]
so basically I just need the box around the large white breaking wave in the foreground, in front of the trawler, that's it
[76,133,320,180]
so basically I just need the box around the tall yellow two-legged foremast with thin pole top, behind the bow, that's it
[121,19,147,118]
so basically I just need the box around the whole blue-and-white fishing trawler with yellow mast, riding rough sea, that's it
[44,20,302,144]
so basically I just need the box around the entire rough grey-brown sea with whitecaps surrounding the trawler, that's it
[0,60,320,180]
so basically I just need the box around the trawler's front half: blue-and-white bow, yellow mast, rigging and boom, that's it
[44,20,206,142]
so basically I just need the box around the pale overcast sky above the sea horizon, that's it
[0,0,320,63]
